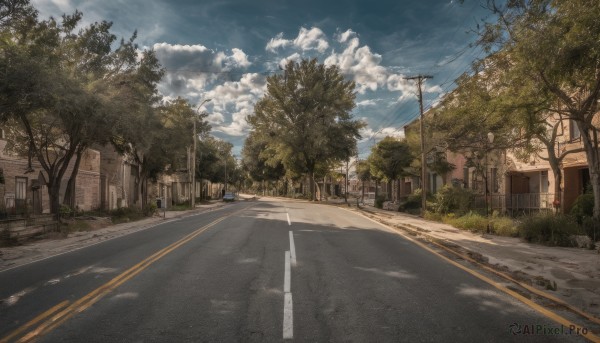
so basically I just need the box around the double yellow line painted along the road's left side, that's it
[0,214,237,343]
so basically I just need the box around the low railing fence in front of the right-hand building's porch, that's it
[474,193,554,216]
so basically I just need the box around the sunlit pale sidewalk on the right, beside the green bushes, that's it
[351,206,600,318]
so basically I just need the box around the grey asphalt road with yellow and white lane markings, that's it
[0,201,581,342]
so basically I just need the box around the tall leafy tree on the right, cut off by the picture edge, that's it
[481,0,600,220]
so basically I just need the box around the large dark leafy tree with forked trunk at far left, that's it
[0,0,162,213]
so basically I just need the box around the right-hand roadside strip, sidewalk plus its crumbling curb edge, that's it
[343,207,600,325]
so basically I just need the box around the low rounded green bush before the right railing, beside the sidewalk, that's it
[518,212,583,246]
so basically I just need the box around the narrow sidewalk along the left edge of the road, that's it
[0,201,230,271]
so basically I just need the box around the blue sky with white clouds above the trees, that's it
[32,0,488,157]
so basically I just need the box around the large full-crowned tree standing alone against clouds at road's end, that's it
[248,59,364,200]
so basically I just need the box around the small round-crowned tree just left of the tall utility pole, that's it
[369,136,413,200]
